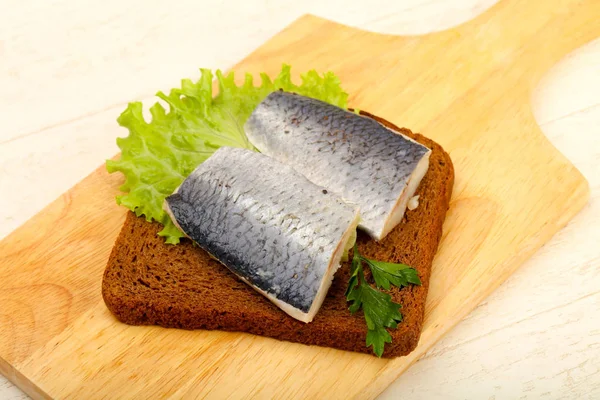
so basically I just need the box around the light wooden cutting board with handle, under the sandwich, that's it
[0,0,600,399]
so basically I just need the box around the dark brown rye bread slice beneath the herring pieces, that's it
[102,113,454,357]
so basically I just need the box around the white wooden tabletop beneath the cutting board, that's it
[0,0,600,400]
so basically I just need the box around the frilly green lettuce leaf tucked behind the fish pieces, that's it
[106,65,348,244]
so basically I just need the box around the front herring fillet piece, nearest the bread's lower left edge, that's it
[164,147,359,322]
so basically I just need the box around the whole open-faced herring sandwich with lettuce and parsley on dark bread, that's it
[102,66,454,357]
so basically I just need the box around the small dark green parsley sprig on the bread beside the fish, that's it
[346,245,421,357]
